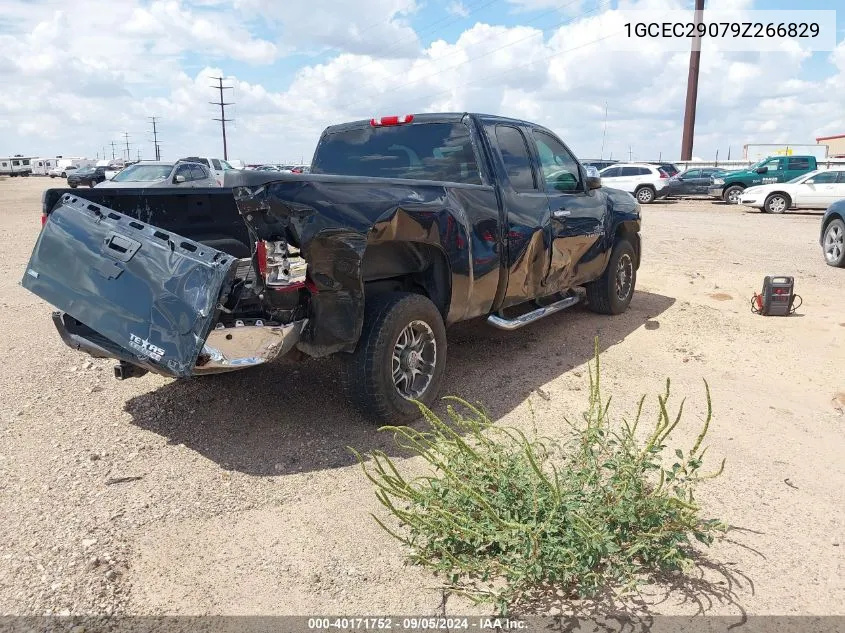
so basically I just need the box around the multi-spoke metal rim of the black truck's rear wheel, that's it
[392,321,437,400]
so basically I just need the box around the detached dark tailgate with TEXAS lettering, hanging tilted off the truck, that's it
[21,194,237,377]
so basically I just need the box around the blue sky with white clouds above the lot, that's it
[0,0,845,163]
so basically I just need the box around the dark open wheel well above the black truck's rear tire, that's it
[361,242,452,319]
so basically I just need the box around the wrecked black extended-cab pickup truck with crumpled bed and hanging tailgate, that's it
[22,114,640,422]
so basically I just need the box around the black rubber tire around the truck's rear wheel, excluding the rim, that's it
[343,292,446,424]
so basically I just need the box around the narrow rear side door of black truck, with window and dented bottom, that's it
[487,123,552,308]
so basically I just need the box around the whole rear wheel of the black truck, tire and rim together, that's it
[343,292,446,423]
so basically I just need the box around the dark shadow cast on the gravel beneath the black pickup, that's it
[124,291,675,476]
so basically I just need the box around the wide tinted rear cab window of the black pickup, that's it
[311,122,483,185]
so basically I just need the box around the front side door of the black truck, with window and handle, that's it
[532,130,608,294]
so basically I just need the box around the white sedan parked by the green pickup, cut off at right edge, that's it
[740,167,845,213]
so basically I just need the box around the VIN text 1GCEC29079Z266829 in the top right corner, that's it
[624,22,821,38]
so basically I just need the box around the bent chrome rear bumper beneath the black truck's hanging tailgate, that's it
[53,312,308,376]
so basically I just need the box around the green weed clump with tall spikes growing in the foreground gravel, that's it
[355,340,725,613]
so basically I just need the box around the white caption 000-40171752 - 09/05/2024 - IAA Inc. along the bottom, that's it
[308,617,528,631]
